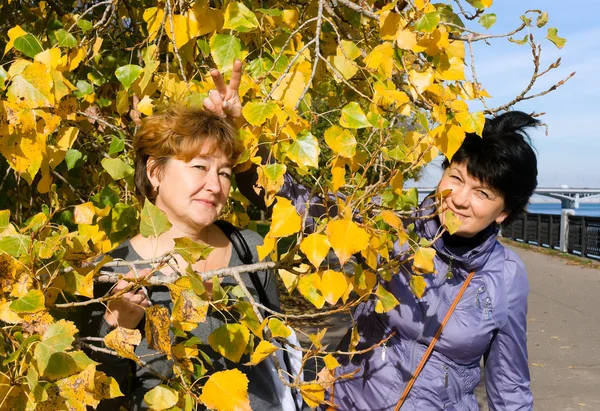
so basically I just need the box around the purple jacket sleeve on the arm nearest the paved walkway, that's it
[484,252,533,411]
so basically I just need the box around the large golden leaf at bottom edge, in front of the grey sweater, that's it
[200,369,252,411]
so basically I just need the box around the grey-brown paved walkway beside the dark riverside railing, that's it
[307,248,600,411]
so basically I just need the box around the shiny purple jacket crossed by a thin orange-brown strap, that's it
[280,180,533,411]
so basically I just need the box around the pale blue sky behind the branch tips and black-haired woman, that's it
[417,0,600,188]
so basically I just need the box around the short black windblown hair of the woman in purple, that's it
[442,111,540,225]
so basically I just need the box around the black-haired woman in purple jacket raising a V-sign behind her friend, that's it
[205,62,539,411]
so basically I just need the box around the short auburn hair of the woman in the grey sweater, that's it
[133,105,243,202]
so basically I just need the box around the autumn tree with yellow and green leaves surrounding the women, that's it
[0,0,568,410]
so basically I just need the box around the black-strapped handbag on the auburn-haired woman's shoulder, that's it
[215,220,302,410]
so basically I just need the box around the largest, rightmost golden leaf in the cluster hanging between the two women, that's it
[327,220,369,265]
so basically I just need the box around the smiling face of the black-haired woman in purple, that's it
[437,163,508,237]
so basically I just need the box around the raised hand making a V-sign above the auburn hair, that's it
[203,60,242,122]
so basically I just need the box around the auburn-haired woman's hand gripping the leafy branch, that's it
[104,268,152,329]
